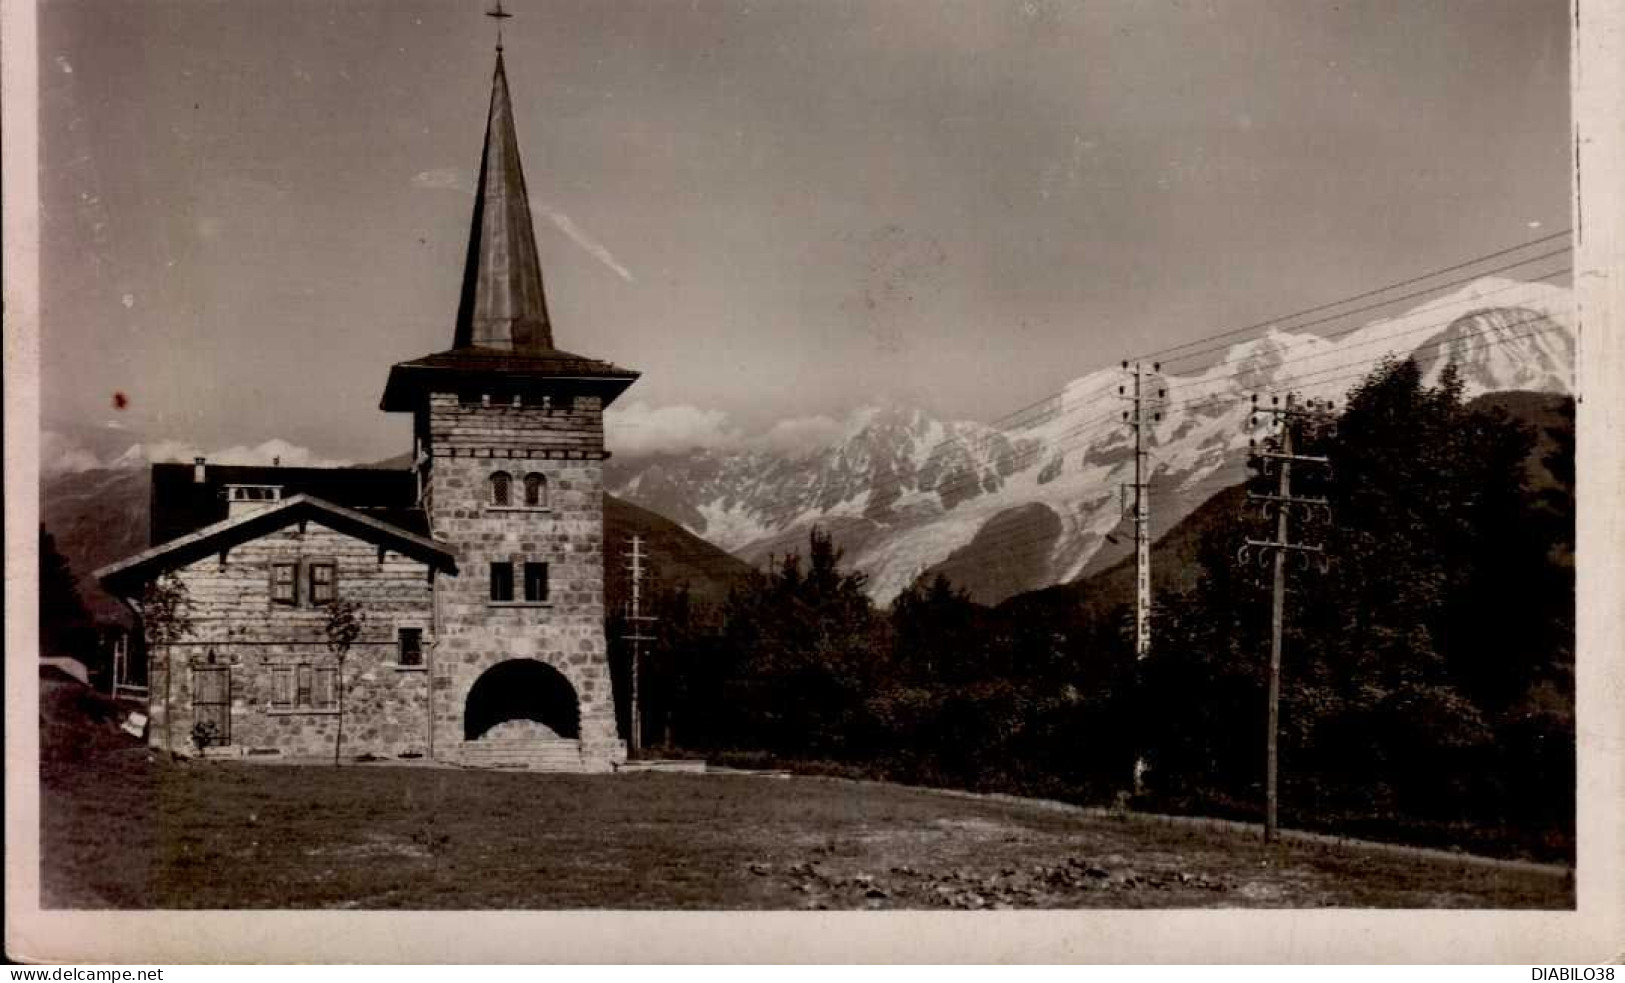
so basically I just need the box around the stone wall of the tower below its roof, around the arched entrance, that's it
[418,393,626,770]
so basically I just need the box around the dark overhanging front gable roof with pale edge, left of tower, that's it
[94,496,457,595]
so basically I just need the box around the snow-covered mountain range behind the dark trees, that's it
[606,278,1575,601]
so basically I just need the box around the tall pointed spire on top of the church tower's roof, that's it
[455,47,553,354]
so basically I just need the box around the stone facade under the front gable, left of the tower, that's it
[148,520,436,756]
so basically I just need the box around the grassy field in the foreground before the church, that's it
[42,747,1573,910]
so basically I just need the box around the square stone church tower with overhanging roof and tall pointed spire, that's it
[382,44,637,770]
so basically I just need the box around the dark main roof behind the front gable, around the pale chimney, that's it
[151,465,429,546]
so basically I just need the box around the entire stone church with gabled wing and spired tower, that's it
[96,45,637,772]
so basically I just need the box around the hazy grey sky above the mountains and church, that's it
[41,0,1570,460]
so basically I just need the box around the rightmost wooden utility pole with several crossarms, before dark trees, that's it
[1240,395,1331,843]
